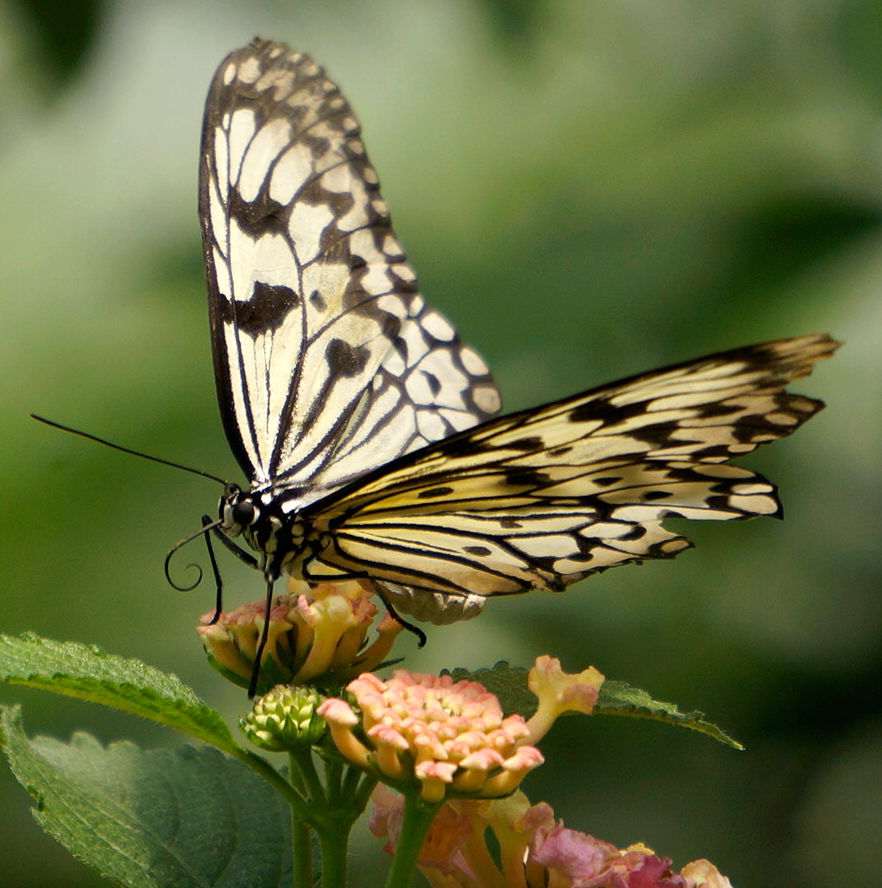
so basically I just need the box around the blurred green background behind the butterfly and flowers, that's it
[0,0,882,888]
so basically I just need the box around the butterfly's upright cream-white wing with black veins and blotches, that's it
[199,41,499,505]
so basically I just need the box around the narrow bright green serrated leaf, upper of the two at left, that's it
[0,633,242,755]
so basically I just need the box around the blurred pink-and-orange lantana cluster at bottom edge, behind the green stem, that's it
[369,785,732,888]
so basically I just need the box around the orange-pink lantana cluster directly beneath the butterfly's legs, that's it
[196,579,402,686]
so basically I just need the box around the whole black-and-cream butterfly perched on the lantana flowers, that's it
[199,40,838,652]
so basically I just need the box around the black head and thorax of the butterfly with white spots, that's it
[218,484,307,579]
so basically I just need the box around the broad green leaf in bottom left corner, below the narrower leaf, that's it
[0,707,291,888]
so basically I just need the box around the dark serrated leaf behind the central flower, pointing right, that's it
[450,661,744,749]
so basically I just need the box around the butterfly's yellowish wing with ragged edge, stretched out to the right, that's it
[306,336,836,621]
